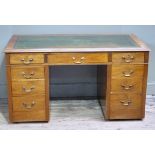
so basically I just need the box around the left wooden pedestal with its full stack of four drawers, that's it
[6,54,49,122]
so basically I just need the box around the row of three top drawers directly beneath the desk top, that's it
[9,52,145,65]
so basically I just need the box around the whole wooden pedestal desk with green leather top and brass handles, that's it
[5,34,150,122]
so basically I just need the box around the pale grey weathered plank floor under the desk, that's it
[0,95,155,130]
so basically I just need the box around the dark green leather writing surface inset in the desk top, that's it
[14,35,138,49]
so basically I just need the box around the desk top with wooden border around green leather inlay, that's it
[5,34,150,53]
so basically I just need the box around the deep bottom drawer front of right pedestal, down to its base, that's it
[110,94,143,119]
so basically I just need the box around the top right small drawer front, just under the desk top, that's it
[112,52,144,64]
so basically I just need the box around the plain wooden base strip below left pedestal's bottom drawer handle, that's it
[12,110,48,122]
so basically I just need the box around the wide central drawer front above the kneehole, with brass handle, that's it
[48,53,108,65]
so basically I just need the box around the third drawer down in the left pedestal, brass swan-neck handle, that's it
[12,80,45,96]
